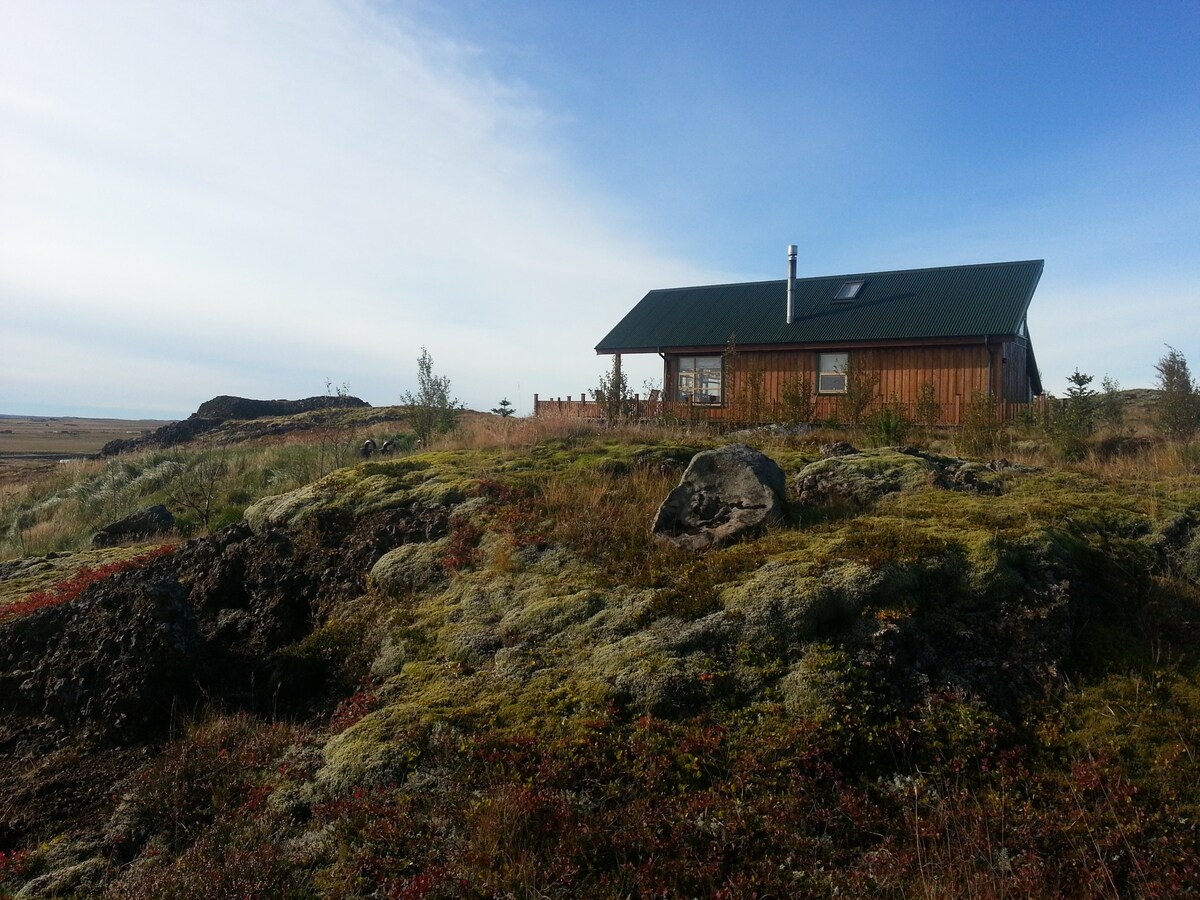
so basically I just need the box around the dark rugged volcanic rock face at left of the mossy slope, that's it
[0,506,449,752]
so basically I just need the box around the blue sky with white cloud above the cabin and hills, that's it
[0,0,1200,419]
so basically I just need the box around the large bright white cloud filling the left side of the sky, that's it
[0,0,714,415]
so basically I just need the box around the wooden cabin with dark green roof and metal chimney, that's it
[535,256,1043,425]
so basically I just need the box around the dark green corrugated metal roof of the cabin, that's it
[596,259,1044,353]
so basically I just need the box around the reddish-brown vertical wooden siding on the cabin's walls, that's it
[534,337,1031,425]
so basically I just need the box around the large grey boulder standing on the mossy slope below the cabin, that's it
[653,444,787,551]
